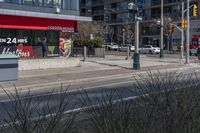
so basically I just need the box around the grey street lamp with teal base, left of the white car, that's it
[128,2,140,70]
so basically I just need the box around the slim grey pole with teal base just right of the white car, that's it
[160,0,164,58]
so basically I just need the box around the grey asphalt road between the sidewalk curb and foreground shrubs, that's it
[0,69,200,125]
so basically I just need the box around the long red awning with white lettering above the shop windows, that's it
[0,14,77,32]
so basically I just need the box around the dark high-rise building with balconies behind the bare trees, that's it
[80,0,200,48]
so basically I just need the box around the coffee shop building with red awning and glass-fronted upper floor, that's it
[0,0,91,58]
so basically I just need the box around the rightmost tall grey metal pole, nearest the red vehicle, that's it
[186,0,190,64]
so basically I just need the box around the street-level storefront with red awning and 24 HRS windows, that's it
[0,15,77,58]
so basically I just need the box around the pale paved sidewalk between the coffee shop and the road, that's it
[0,55,200,90]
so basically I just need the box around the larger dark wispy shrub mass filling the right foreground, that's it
[81,71,200,133]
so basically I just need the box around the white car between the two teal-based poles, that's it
[139,45,160,54]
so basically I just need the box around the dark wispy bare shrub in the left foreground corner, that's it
[1,88,79,133]
